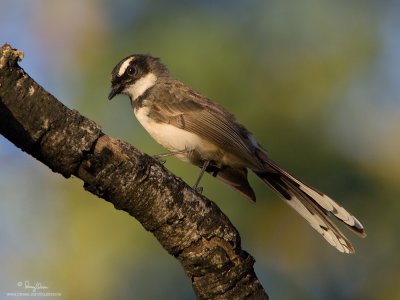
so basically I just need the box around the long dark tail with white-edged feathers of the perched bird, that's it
[255,152,367,253]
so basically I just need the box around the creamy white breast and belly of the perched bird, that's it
[134,107,218,159]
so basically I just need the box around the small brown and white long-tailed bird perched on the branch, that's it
[108,54,366,253]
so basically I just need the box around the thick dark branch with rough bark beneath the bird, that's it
[0,44,268,299]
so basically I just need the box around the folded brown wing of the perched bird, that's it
[148,82,262,169]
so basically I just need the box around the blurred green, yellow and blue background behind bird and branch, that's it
[0,0,400,299]
